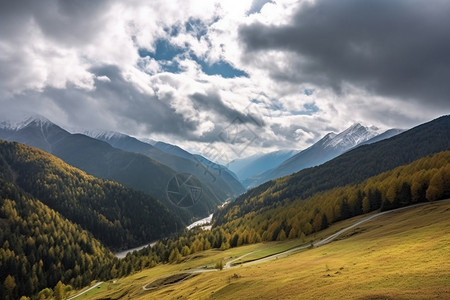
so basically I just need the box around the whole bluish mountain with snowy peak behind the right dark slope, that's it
[247,123,397,187]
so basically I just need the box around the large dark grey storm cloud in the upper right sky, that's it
[239,0,450,108]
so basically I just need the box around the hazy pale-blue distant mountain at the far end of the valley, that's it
[227,150,298,181]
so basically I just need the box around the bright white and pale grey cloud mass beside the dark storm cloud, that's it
[0,0,441,160]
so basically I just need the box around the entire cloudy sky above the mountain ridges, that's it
[0,0,450,162]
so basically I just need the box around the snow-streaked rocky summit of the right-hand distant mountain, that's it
[325,123,380,149]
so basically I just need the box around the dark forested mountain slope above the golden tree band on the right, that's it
[215,116,450,224]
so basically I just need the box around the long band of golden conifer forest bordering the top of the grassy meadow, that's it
[117,151,450,282]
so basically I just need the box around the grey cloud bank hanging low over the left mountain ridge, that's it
[2,66,198,138]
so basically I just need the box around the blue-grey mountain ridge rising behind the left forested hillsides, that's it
[0,117,219,223]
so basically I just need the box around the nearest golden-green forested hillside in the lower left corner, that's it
[0,179,115,300]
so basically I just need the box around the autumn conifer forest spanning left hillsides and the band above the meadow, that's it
[0,142,450,299]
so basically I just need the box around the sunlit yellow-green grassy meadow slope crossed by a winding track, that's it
[67,201,450,300]
